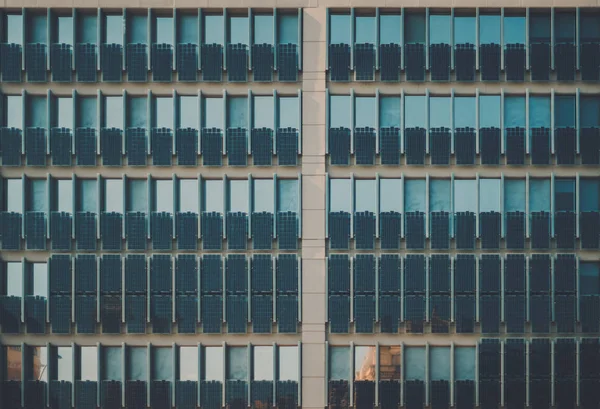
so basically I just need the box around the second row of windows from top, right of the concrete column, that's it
[327,91,600,165]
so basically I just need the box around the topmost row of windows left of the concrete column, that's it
[0,9,302,82]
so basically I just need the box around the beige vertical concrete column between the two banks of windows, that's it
[302,6,327,409]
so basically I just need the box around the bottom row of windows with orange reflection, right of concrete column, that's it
[328,338,588,409]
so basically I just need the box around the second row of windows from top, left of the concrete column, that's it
[0,93,301,166]
